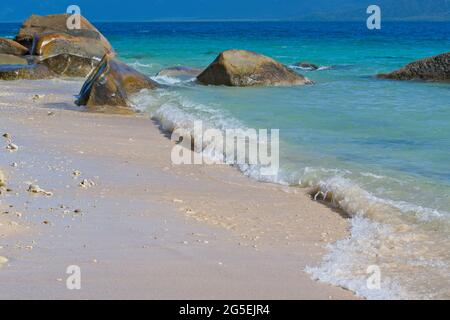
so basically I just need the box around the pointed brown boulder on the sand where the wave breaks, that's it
[76,56,158,111]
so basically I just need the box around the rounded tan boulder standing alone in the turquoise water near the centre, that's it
[197,50,312,87]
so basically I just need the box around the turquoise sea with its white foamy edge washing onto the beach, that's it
[0,22,450,298]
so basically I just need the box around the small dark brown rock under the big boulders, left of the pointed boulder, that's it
[39,53,98,78]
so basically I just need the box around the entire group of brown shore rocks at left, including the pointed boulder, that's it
[0,14,157,108]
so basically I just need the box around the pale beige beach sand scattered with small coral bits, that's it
[0,80,355,299]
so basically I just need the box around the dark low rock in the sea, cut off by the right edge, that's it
[378,52,450,81]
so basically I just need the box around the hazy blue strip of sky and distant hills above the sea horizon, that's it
[0,0,450,21]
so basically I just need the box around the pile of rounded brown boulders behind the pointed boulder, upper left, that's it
[0,14,114,80]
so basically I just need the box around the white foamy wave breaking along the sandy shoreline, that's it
[129,90,450,299]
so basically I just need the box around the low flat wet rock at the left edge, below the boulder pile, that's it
[0,64,56,80]
